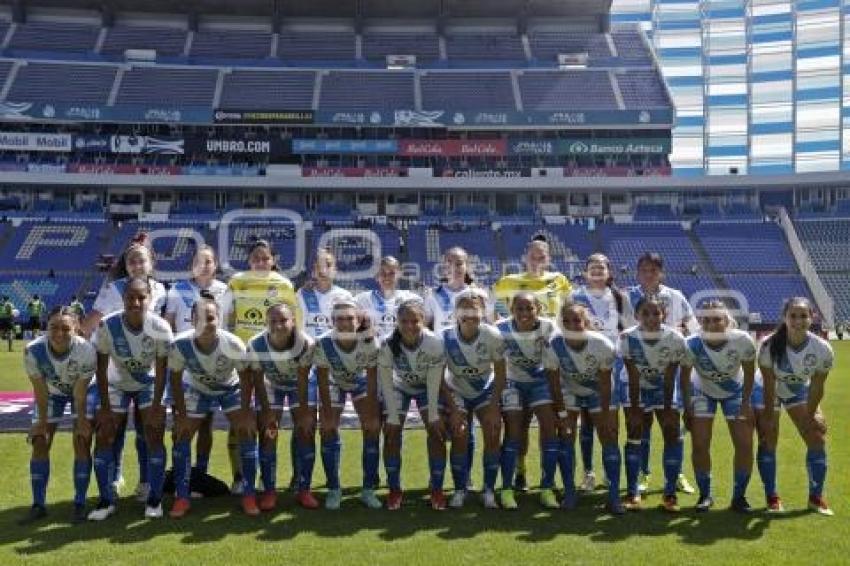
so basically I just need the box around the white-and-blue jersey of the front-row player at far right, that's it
[758,332,835,399]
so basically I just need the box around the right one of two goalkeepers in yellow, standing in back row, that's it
[493,236,571,491]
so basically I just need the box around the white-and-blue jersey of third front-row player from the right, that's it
[619,324,685,389]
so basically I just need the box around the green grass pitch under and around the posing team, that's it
[0,342,850,566]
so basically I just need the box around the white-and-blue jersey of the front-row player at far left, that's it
[24,336,97,397]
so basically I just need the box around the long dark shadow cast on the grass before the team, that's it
[0,490,808,556]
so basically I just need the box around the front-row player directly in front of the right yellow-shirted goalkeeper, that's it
[497,292,560,509]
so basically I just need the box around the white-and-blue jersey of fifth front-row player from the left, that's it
[313,330,380,391]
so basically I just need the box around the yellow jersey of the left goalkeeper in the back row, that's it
[227,271,299,343]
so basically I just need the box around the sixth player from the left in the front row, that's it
[378,299,454,511]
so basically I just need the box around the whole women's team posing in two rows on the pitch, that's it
[23,234,833,521]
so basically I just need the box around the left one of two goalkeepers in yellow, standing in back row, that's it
[223,239,297,495]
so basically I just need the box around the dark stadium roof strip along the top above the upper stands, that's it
[0,0,612,19]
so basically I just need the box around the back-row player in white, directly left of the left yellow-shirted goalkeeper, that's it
[165,245,230,486]
